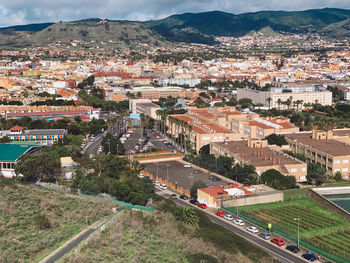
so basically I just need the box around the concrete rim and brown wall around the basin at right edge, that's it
[307,187,350,220]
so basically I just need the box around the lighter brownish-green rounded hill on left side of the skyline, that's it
[0,19,169,46]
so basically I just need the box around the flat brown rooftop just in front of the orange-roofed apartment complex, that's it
[213,141,302,166]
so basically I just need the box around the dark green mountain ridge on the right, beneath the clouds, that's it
[145,8,350,43]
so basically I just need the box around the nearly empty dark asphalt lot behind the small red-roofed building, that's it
[145,161,234,190]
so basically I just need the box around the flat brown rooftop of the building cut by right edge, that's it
[284,132,350,156]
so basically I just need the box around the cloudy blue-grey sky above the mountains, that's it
[0,0,350,27]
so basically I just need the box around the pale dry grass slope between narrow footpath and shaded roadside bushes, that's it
[60,207,273,263]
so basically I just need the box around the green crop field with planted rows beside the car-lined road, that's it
[224,198,350,262]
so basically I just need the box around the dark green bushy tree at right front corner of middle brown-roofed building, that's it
[261,169,296,190]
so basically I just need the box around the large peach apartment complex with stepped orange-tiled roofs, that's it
[167,107,299,151]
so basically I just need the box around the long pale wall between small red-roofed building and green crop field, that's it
[221,191,284,207]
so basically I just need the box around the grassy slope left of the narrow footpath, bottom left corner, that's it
[0,180,114,263]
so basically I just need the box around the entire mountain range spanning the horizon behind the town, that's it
[0,8,350,45]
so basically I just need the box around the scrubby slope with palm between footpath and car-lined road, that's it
[65,198,274,263]
